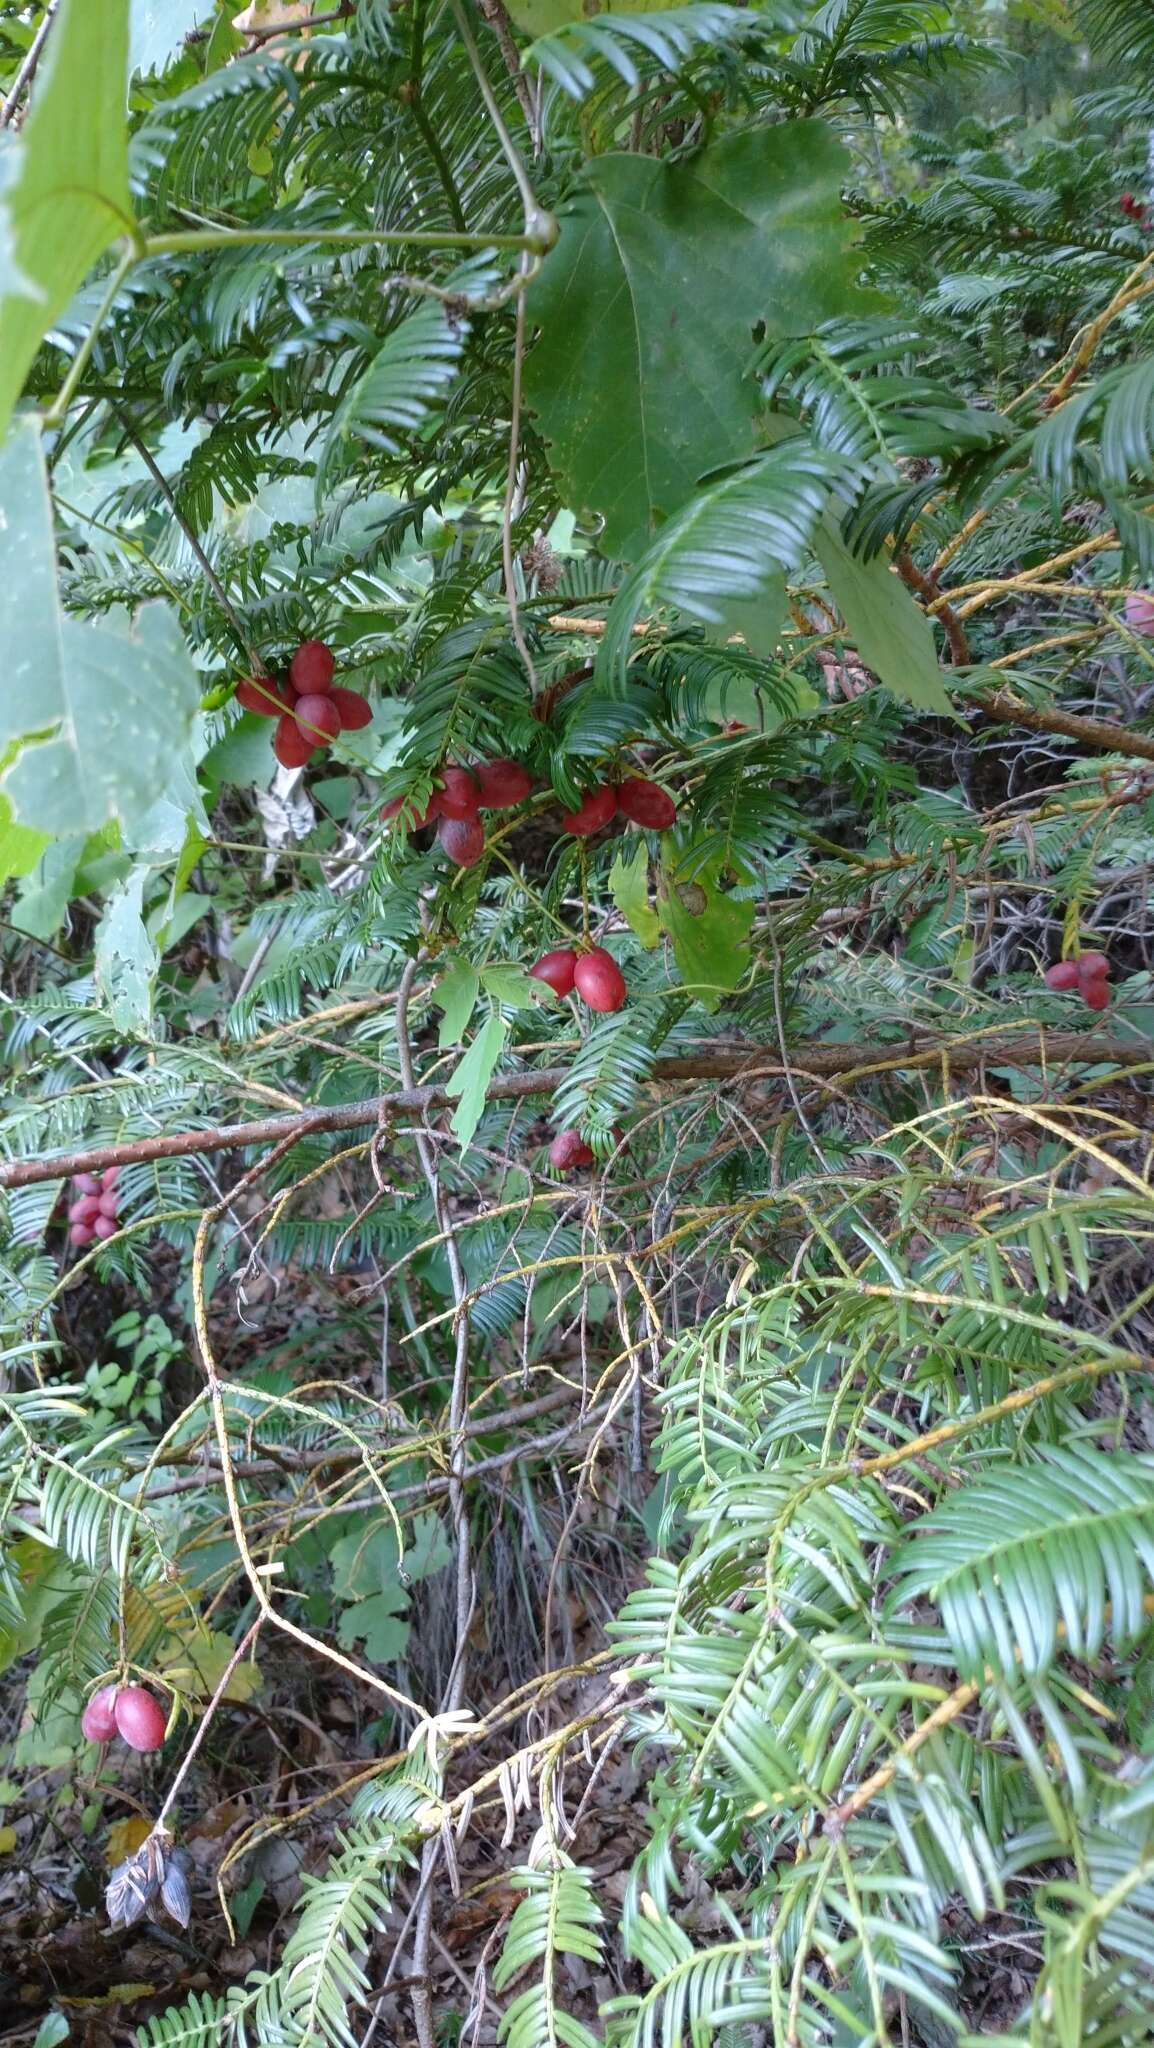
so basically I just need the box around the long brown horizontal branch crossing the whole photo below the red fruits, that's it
[0,1024,1150,1188]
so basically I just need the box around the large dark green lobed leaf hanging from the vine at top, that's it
[525,121,857,561]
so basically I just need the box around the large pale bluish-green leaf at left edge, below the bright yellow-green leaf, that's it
[0,418,199,844]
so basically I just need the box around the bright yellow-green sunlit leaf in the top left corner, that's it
[0,0,133,434]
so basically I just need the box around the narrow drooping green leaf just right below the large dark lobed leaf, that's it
[814,518,955,719]
